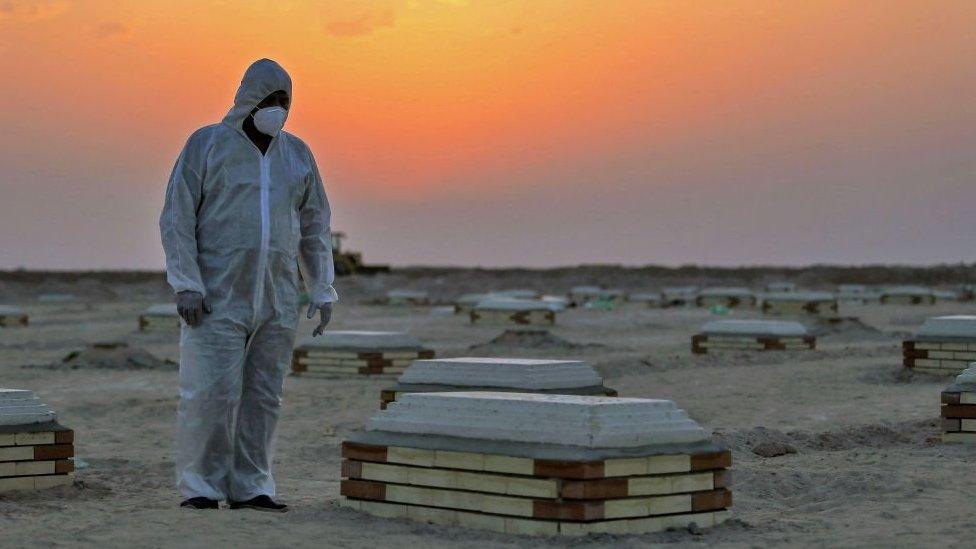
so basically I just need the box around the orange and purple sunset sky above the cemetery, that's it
[0,0,976,269]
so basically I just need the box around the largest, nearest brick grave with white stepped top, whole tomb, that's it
[340,393,732,536]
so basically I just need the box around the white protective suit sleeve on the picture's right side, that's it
[298,148,339,305]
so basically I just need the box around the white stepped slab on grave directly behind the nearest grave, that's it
[399,357,603,390]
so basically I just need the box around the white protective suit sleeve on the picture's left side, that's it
[159,137,206,295]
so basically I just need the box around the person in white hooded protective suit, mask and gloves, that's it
[159,59,338,511]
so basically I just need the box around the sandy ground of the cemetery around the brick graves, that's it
[0,280,976,547]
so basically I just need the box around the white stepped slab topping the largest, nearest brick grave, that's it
[366,392,707,448]
